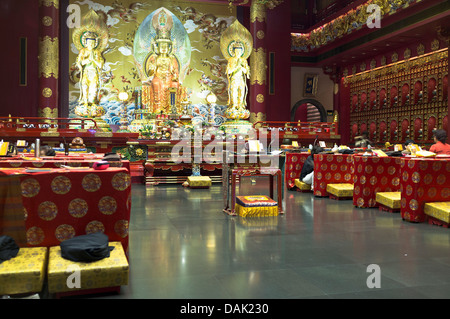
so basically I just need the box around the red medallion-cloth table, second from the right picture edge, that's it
[353,155,402,208]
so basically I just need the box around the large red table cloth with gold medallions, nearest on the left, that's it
[0,168,131,255]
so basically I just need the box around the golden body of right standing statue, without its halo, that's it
[227,42,250,111]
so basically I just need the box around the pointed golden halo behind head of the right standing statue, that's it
[220,20,253,60]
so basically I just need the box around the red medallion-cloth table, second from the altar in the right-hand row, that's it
[314,154,355,197]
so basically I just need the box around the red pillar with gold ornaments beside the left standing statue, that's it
[37,0,60,118]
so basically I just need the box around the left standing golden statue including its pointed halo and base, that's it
[72,10,108,118]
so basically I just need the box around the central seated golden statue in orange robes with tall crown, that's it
[144,10,186,114]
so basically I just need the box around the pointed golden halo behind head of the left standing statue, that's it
[72,10,109,52]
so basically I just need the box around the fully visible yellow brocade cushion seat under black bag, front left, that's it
[48,242,129,293]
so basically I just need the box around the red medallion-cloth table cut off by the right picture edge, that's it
[400,157,450,222]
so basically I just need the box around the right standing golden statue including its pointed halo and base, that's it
[220,20,253,120]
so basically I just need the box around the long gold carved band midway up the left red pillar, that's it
[38,36,59,79]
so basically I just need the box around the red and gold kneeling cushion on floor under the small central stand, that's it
[235,195,278,217]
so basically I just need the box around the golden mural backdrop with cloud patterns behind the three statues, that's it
[68,0,236,124]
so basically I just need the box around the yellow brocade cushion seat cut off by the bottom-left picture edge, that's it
[0,247,48,295]
